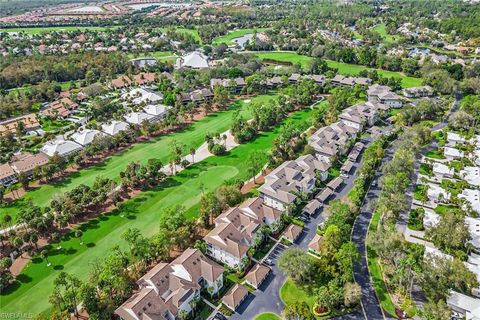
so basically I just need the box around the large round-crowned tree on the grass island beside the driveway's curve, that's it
[278,248,316,284]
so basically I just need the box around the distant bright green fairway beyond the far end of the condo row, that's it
[249,51,422,88]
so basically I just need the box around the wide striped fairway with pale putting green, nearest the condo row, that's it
[0,105,311,314]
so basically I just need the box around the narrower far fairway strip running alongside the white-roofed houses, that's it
[0,95,273,220]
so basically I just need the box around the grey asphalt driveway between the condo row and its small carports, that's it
[229,138,371,320]
